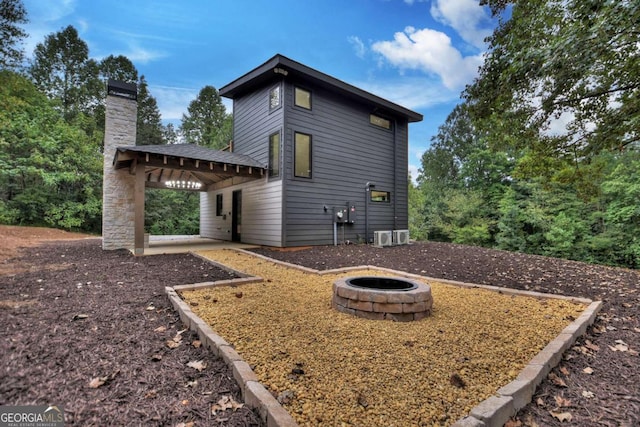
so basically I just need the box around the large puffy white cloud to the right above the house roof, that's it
[372,27,483,91]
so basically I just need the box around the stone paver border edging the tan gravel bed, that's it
[165,249,603,427]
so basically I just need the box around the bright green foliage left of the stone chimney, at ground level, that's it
[0,72,102,232]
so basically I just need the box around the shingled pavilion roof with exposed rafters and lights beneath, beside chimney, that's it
[113,144,267,191]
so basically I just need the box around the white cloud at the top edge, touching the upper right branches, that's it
[431,0,493,49]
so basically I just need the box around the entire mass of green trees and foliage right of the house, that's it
[411,0,640,268]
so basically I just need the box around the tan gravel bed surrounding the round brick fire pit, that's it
[183,251,584,426]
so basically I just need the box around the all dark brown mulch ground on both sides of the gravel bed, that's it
[0,226,640,427]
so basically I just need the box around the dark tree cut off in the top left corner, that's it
[0,0,28,69]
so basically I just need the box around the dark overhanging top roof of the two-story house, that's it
[219,54,423,122]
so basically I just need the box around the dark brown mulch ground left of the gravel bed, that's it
[0,239,261,426]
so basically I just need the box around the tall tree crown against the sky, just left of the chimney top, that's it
[29,25,102,121]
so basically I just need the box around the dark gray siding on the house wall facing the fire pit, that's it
[283,82,408,246]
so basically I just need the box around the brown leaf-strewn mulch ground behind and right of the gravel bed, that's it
[255,242,640,427]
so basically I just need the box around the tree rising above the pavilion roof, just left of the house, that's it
[180,86,231,149]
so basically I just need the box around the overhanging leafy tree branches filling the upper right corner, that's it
[465,0,640,160]
